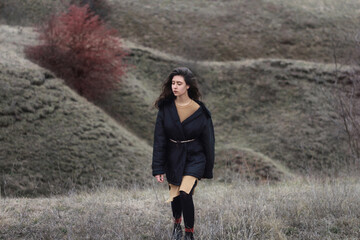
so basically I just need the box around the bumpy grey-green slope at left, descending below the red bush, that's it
[0,26,151,196]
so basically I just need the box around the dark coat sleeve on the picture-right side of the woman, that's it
[201,117,215,178]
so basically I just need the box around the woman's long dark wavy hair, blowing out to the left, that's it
[154,67,201,108]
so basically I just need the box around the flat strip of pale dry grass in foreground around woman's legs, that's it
[0,178,360,239]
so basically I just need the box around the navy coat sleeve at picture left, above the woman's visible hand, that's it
[152,109,168,176]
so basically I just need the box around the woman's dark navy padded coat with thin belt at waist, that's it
[152,99,215,185]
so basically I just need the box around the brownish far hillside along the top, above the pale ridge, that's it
[0,0,360,63]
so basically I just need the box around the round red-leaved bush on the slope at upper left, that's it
[25,5,126,100]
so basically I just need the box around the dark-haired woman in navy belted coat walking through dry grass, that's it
[152,67,215,239]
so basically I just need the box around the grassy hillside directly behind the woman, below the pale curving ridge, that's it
[97,43,351,173]
